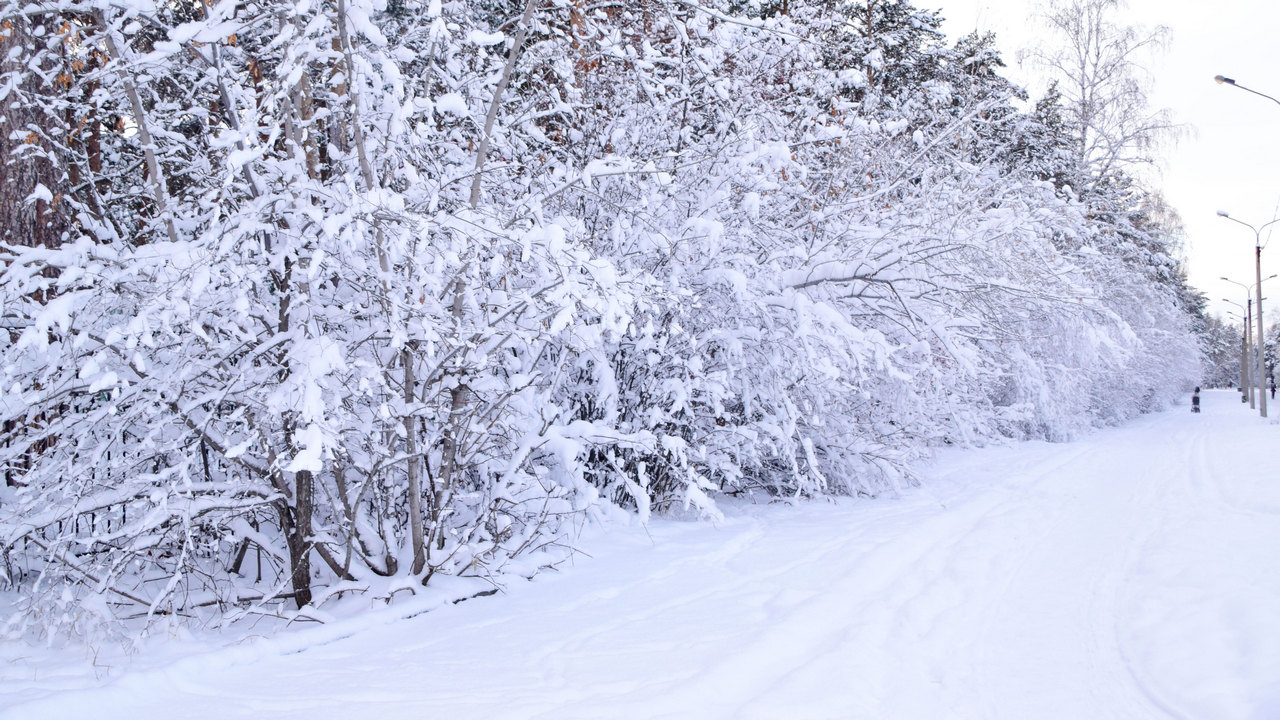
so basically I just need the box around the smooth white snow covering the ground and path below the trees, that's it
[0,391,1280,720]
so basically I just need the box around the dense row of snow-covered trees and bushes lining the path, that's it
[0,0,1203,634]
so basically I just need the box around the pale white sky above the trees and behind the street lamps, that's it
[915,0,1280,325]
